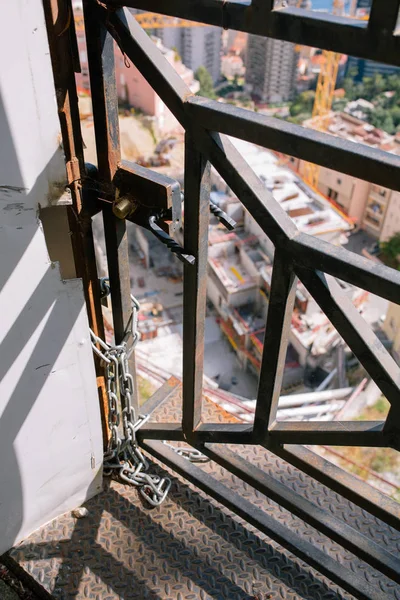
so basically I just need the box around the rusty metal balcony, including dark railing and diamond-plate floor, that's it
[5,0,400,600]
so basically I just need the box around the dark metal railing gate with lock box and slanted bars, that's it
[76,0,400,598]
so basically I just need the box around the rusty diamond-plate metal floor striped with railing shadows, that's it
[6,388,400,600]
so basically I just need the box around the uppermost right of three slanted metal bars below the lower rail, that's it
[272,444,400,530]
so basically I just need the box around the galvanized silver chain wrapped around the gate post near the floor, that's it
[90,296,171,506]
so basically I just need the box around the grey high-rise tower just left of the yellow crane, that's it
[246,0,311,102]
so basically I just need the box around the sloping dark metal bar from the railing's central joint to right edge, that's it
[290,233,400,304]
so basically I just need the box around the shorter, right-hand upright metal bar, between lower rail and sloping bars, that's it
[254,249,297,440]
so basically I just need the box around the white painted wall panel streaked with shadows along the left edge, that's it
[0,0,102,554]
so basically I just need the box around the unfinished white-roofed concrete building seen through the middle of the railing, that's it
[207,139,352,387]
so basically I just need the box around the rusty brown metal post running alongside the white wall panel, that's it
[43,0,108,446]
